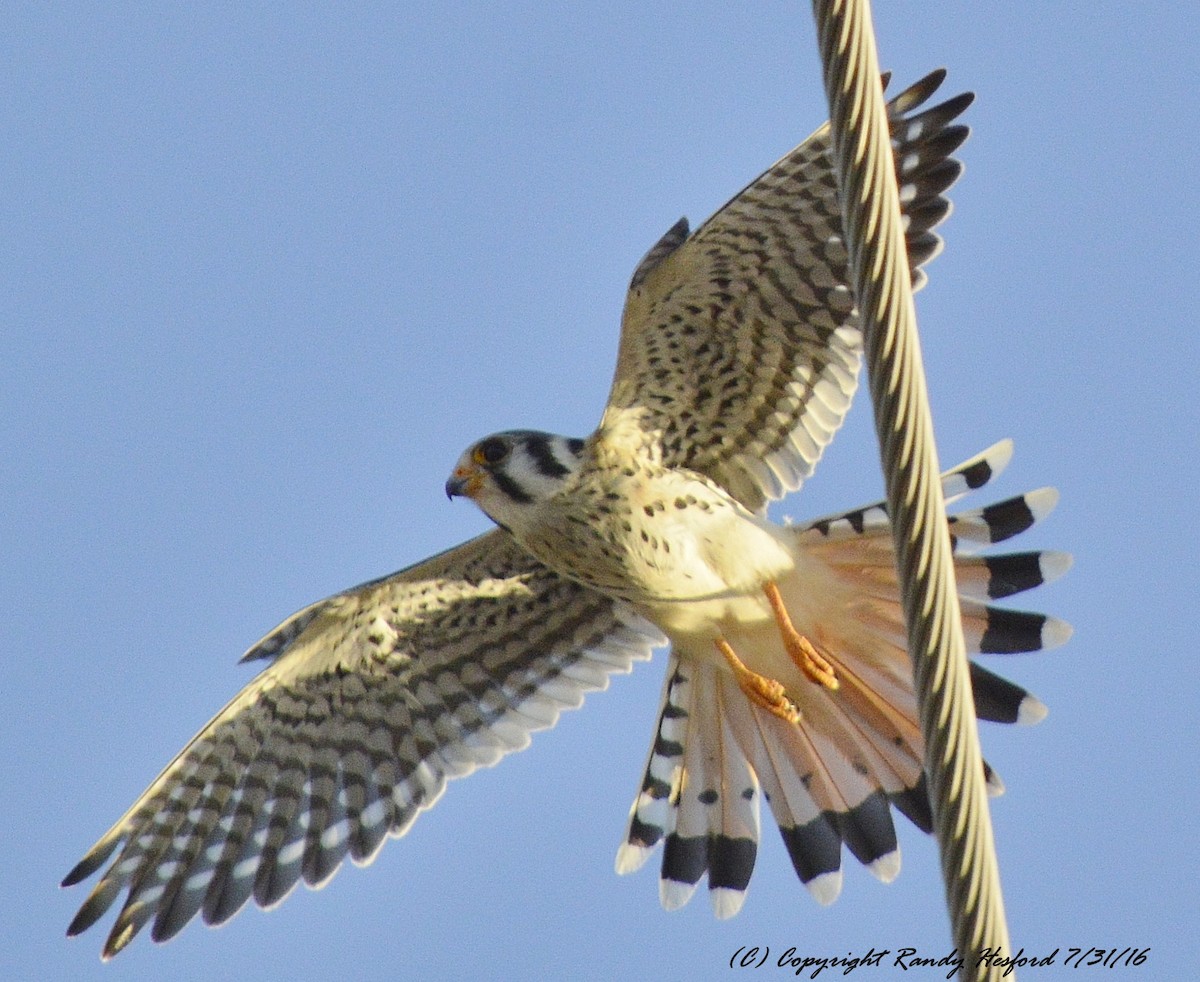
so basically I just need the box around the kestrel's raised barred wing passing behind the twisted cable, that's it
[601,72,972,510]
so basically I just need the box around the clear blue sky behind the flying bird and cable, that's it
[0,0,1200,980]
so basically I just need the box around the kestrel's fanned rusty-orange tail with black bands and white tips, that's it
[617,441,1070,917]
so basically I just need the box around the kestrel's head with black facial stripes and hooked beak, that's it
[446,430,584,529]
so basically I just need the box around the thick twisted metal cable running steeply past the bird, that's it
[812,0,1010,978]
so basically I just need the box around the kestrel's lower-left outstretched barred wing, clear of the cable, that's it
[64,529,662,958]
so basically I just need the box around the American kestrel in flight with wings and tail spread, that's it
[65,72,1068,958]
